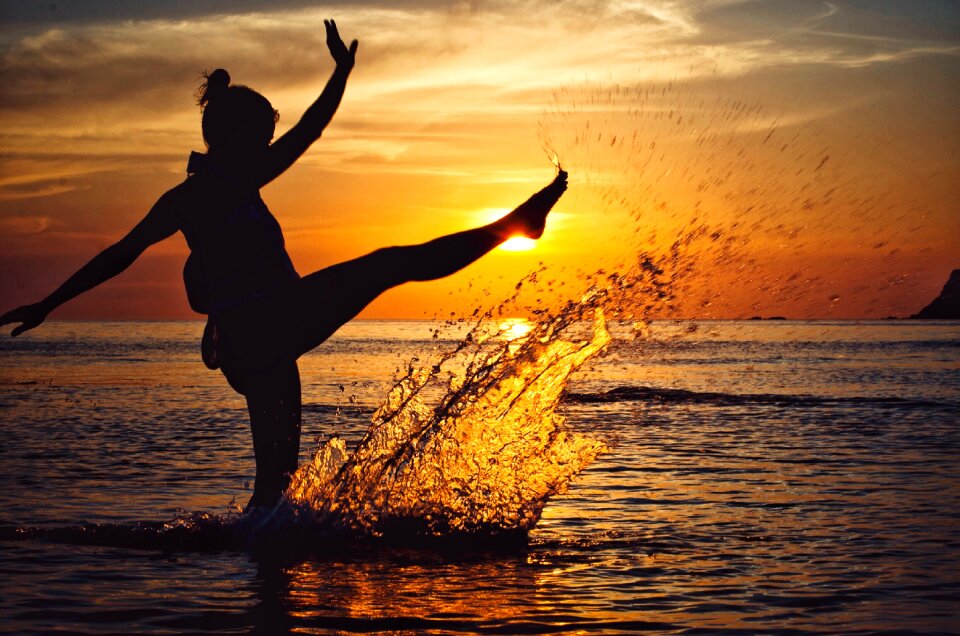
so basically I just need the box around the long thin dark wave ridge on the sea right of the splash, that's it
[563,386,960,409]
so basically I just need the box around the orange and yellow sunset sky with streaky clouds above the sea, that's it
[0,0,960,319]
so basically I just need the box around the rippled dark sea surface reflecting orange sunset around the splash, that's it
[0,321,960,634]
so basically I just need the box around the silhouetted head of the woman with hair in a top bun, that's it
[197,68,280,151]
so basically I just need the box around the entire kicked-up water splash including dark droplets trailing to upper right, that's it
[287,108,736,538]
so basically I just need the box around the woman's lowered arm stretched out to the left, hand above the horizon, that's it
[0,192,179,336]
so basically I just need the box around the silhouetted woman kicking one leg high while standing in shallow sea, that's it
[0,20,566,509]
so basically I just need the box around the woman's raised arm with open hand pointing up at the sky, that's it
[260,20,357,186]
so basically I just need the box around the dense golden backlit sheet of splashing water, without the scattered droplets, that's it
[287,304,610,536]
